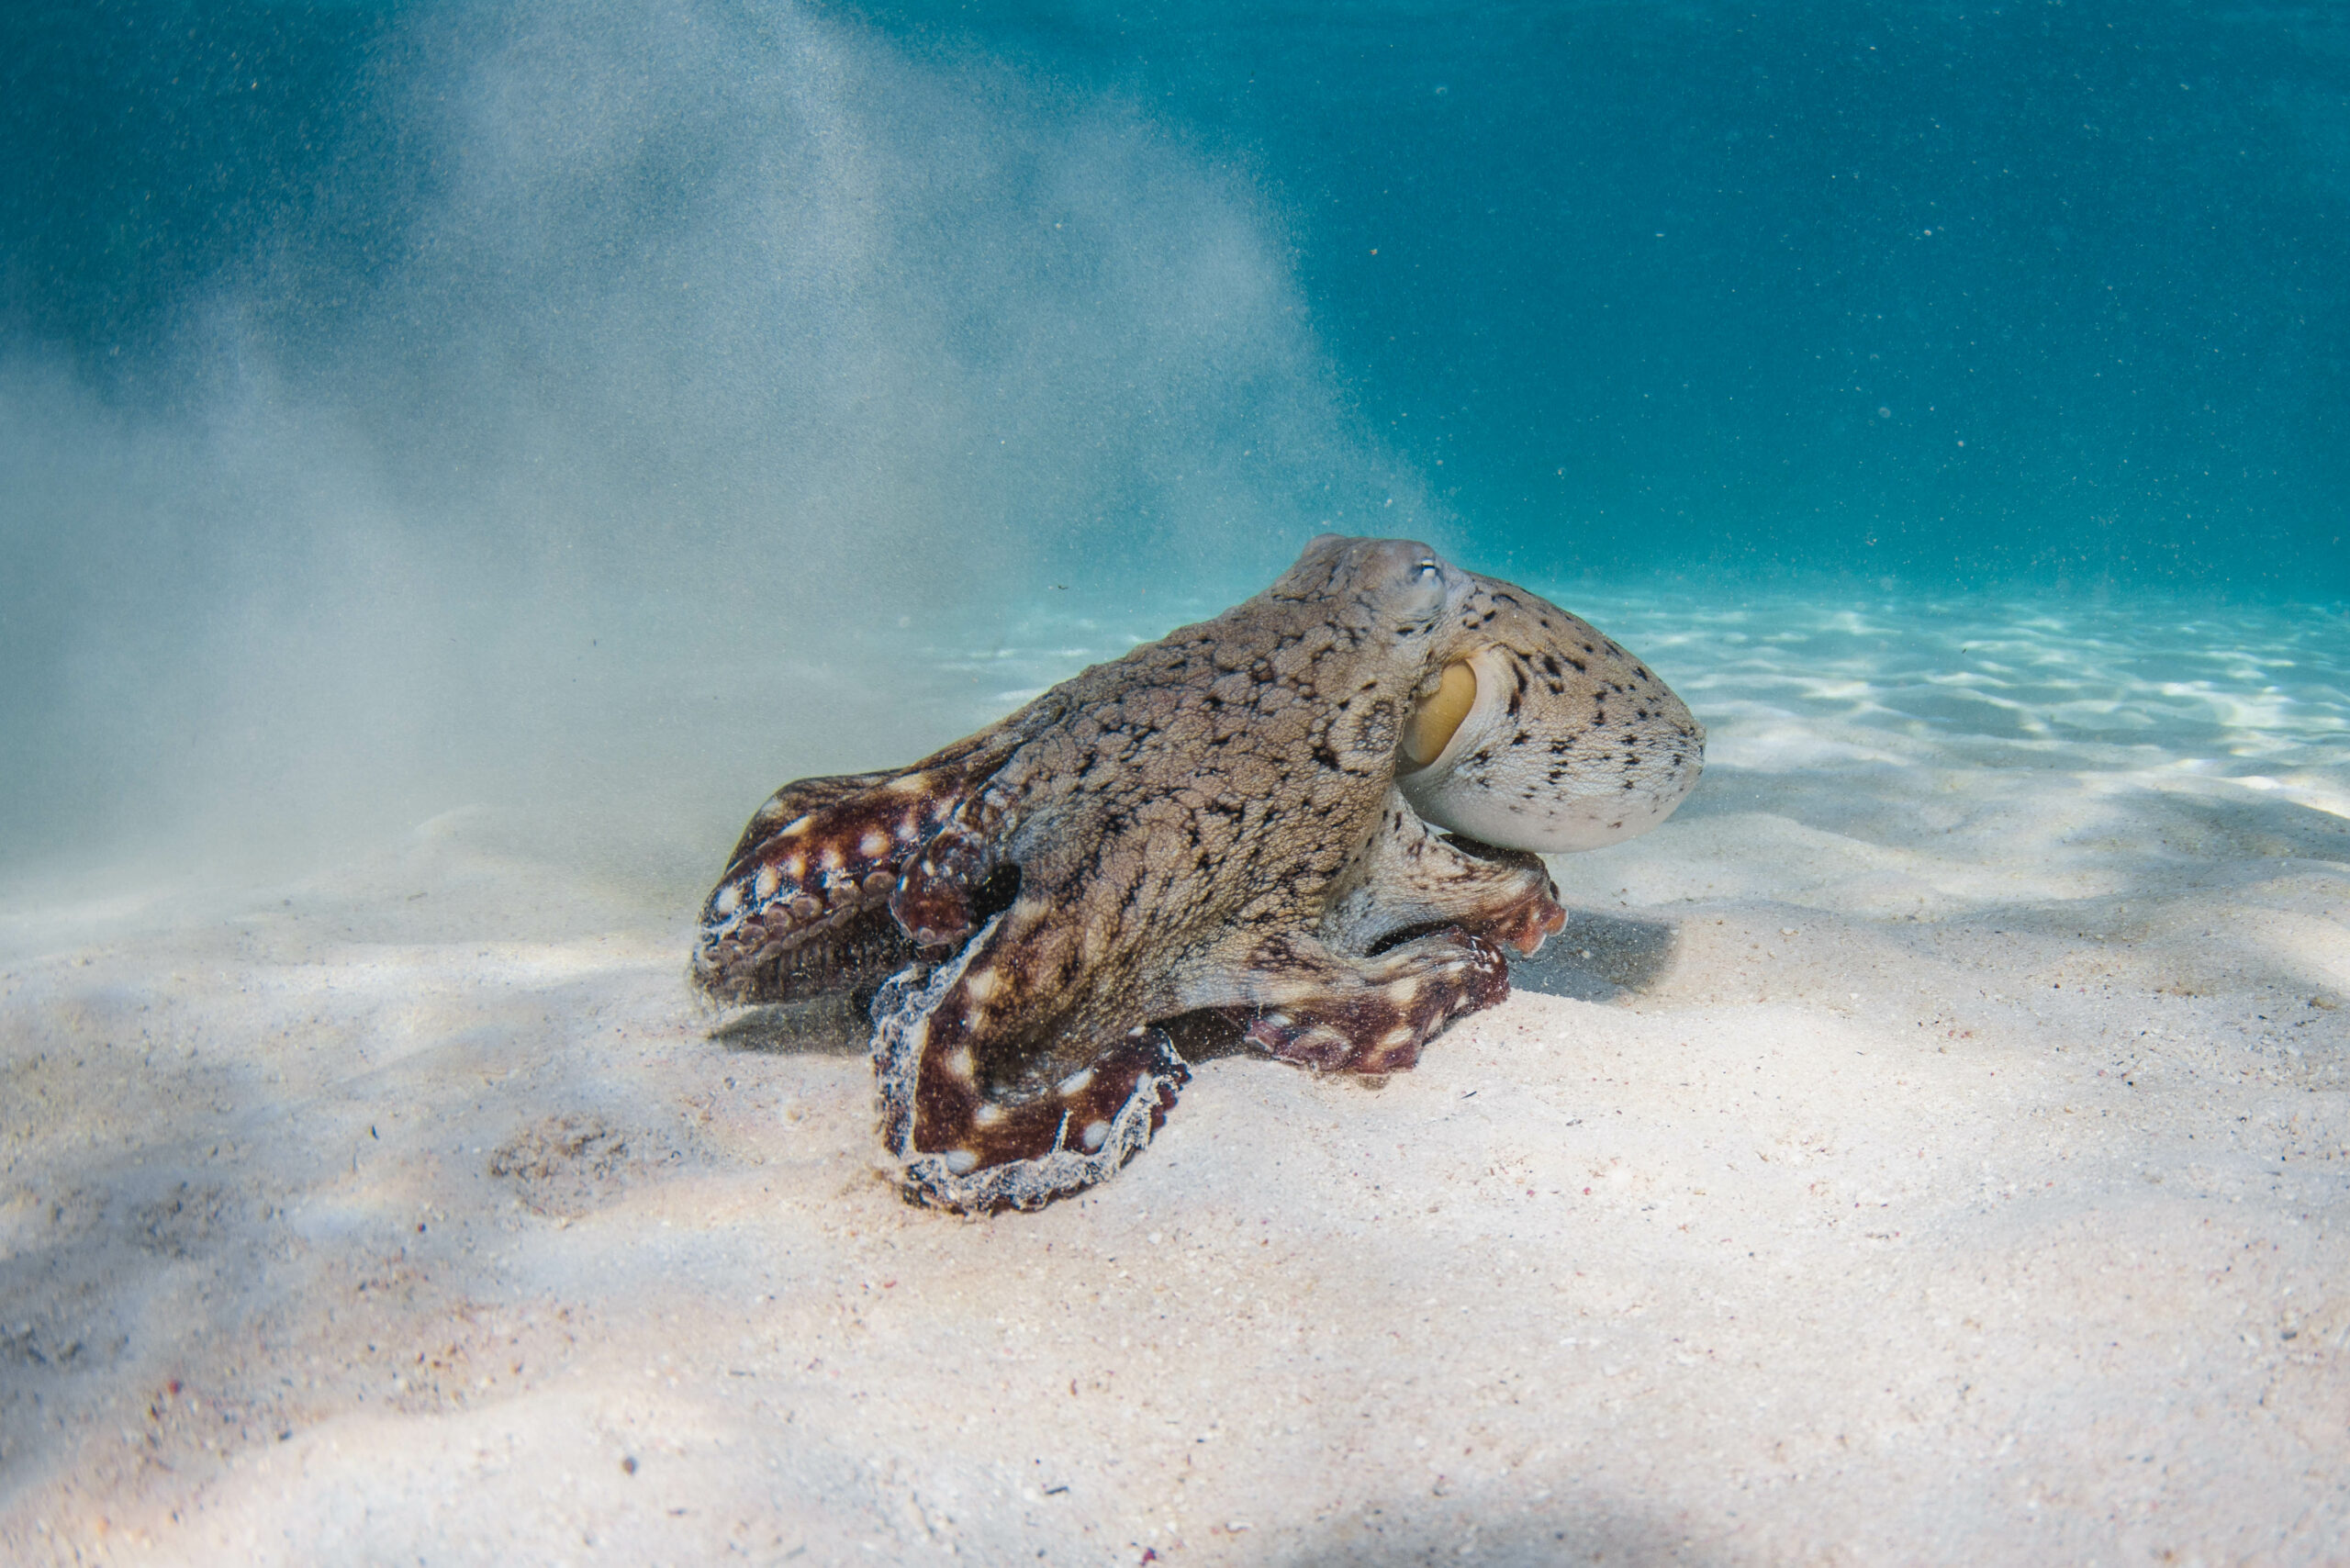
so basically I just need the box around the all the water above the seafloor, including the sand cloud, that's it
[0,0,2350,858]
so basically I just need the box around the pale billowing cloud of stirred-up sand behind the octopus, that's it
[0,0,1434,883]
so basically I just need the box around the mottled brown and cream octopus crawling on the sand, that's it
[691,533,1707,1213]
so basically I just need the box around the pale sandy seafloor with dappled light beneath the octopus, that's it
[0,590,2350,1565]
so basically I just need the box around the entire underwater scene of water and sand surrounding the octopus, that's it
[0,0,2350,1568]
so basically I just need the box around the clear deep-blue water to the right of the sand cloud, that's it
[883,3,2350,597]
